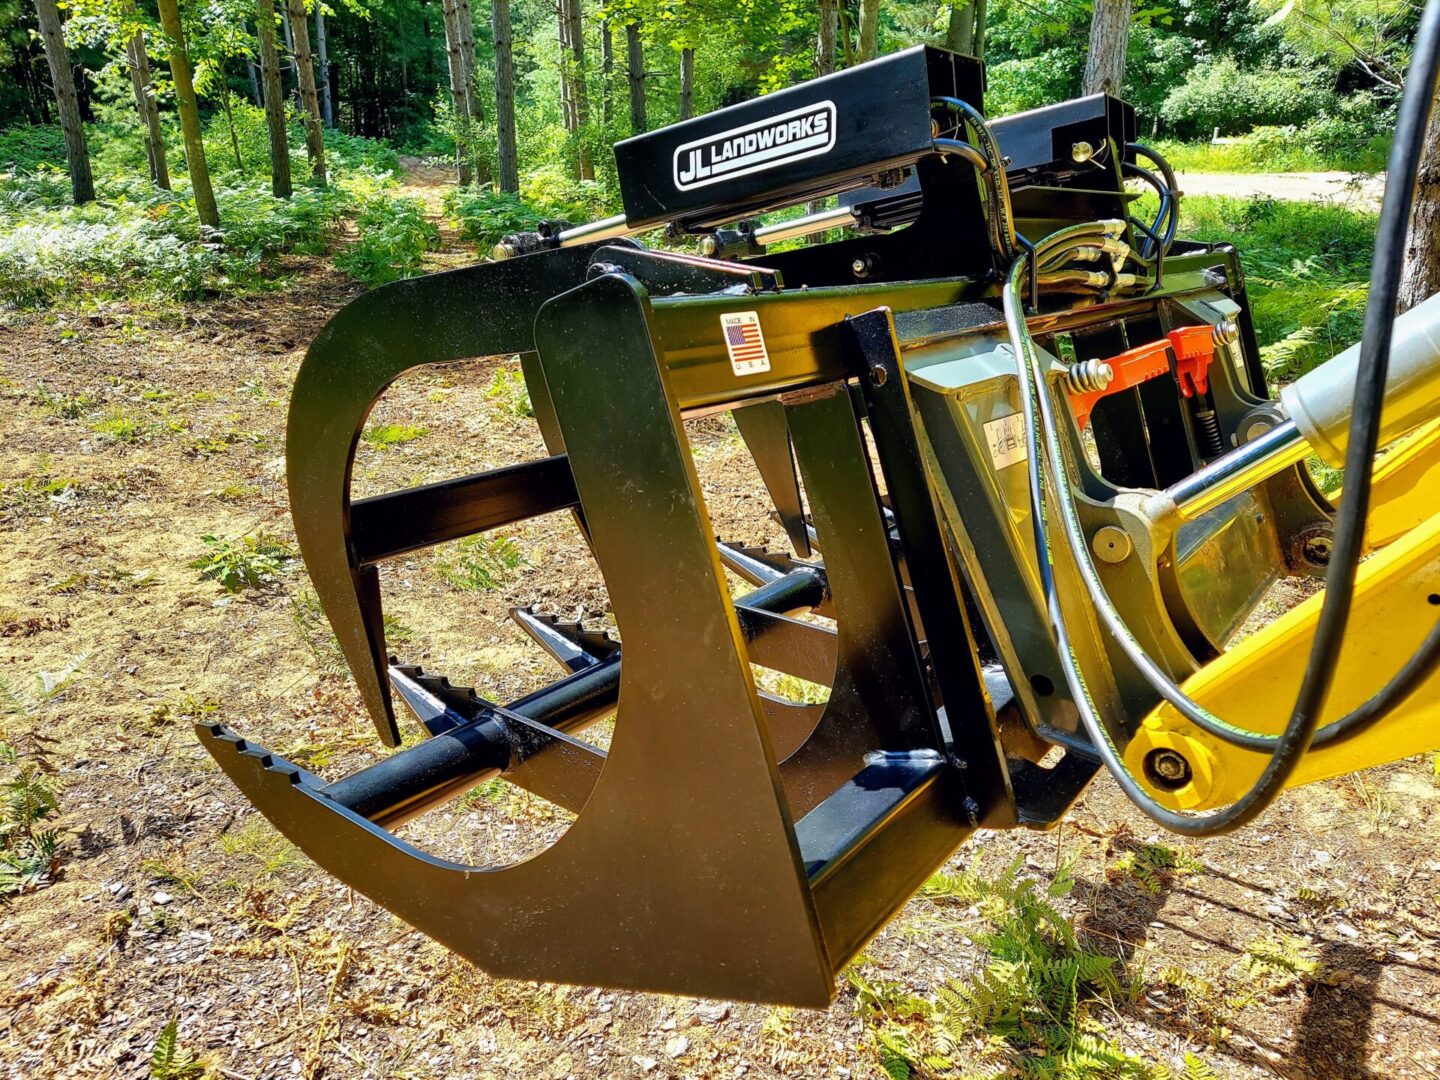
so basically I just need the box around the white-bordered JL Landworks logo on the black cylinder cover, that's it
[675,101,835,192]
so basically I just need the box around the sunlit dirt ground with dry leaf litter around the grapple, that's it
[0,197,1440,1080]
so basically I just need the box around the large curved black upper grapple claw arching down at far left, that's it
[287,245,595,746]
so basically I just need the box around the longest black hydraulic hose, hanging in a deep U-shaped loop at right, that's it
[1004,0,1440,837]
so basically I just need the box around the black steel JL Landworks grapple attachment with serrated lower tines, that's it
[199,48,1301,1007]
